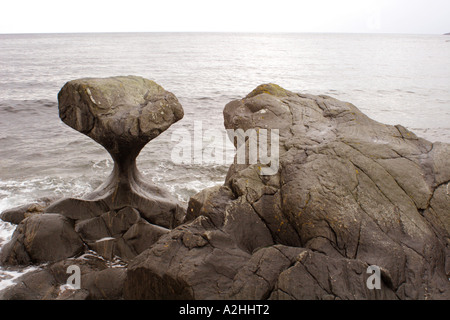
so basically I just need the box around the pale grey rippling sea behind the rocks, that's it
[0,33,450,290]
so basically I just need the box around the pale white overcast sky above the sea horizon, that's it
[0,0,450,34]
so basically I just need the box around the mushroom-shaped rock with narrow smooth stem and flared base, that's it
[37,76,184,262]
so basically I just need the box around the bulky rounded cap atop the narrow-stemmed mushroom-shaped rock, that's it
[58,76,183,156]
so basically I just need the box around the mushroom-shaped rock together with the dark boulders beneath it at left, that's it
[0,76,184,265]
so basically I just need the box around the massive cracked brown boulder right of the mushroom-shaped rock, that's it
[124,84,450,299]
